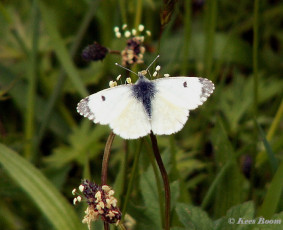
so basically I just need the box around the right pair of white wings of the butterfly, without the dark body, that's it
[151,77,214,135]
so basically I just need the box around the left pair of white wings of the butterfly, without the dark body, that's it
[77,85,150,139]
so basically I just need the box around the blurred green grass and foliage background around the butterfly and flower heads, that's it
[0,0,283,230]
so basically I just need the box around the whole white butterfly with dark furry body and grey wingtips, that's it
[77,61,214,139]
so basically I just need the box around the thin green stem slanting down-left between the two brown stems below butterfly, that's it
[122,140,142,221]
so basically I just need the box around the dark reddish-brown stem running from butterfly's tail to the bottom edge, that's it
[150,132,170,230]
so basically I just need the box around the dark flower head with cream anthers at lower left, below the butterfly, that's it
[72,180,121,229]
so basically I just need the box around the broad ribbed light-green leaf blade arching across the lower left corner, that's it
[0,144,81,230]
